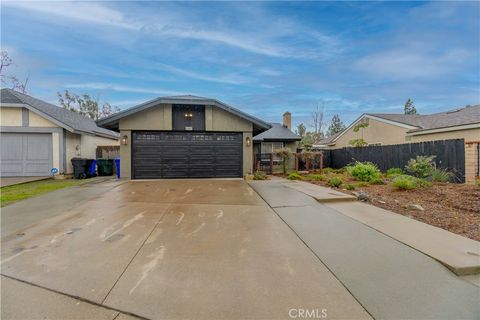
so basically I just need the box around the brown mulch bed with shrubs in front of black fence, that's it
[310,181,480,241]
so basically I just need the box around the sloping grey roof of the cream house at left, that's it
[0,88,119,139]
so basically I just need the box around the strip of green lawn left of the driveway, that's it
[0,179,89,207]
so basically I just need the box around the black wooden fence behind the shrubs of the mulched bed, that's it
[323,139,465,182]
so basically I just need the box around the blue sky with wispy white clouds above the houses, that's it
[1,1,480,128]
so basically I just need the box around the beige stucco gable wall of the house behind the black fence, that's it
[330,119,408,149]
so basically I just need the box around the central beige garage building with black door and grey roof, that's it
[97,95,271,179]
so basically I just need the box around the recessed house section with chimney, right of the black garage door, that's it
[253,112,302,167]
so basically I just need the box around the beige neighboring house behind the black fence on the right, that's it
[326,105,480,181]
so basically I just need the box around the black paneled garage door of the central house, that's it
[132,131,243,179]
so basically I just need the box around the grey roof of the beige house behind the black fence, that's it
[326,105,480,144]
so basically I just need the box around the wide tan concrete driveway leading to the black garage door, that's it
[1,180,370,319]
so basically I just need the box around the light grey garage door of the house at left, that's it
[0,133,52,177]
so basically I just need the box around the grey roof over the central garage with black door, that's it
[97,95,271,131]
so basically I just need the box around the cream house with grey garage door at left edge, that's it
[0,89,119,177]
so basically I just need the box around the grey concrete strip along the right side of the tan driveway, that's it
[250,181,480,319]
